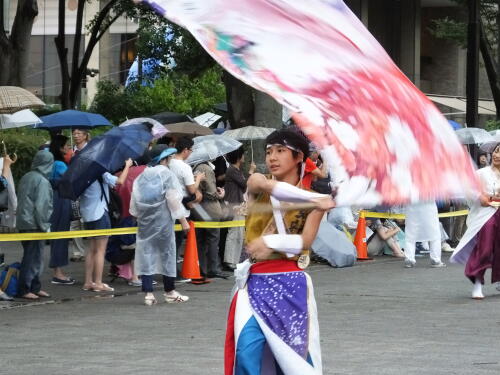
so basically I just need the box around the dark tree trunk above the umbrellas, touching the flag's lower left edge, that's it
[222,71,255,129]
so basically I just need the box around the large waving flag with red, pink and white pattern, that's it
[138,0,479,205]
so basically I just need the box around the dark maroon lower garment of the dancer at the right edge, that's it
[465,209,500,284]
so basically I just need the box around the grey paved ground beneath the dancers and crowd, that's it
[0,244,500,375]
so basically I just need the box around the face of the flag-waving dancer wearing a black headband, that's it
[266,145,303,181]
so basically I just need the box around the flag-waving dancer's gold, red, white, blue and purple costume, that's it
[224,182,322,375]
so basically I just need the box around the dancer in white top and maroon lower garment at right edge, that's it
[450,143,500,299]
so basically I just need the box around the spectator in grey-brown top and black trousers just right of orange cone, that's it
[193,157,227,279]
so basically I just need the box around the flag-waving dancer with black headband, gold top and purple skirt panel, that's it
[224,130,334,375]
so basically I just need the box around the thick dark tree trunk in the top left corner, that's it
[0,0,38,87]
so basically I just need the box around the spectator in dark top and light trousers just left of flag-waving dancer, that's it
[224,146,256,270]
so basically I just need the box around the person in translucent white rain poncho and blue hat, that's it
[130,148,189,306]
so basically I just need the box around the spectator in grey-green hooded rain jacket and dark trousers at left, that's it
[16,151,54,300]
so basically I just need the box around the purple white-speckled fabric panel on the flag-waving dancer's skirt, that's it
[247,271,309,358]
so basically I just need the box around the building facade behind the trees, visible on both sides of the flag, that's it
[2,0,491,113]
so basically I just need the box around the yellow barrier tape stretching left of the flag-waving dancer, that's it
[0,220,245,242]
